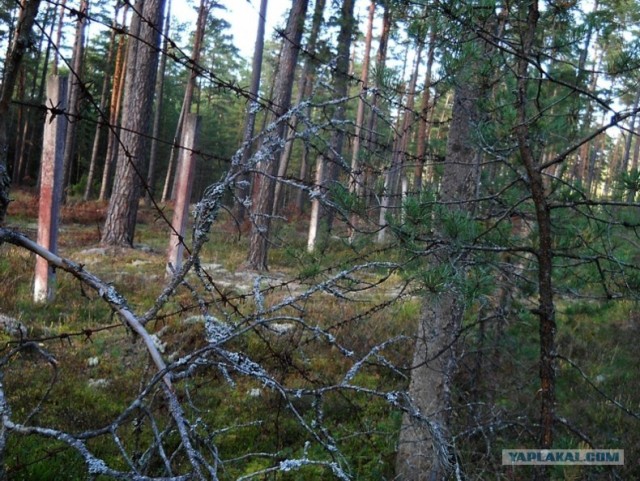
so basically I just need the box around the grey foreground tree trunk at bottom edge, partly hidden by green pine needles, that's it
[396,75,479,481]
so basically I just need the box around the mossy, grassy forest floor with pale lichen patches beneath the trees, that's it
[0,192,640,481]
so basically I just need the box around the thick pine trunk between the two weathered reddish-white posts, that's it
[101,0,164,246]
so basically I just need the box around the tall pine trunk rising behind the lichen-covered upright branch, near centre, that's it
[247,0,309,271]
